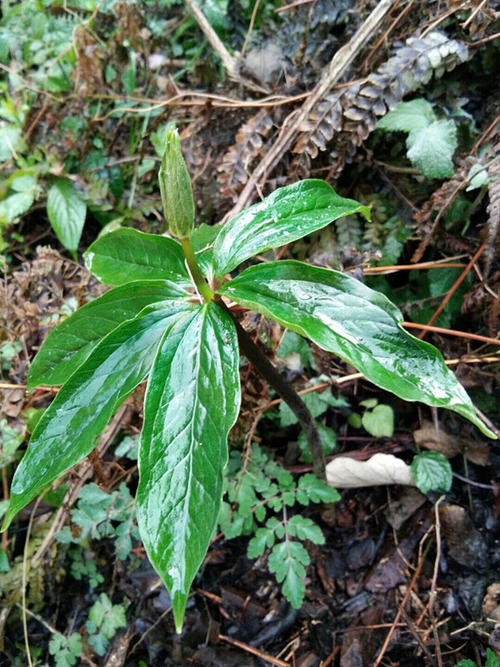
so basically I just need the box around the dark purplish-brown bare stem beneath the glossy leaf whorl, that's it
[222,301,326,479]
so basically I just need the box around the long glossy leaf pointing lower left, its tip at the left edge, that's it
[4,303,189,528]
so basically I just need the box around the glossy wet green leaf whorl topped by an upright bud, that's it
[4,130,495,631]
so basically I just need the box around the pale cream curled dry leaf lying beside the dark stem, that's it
[326,454,415,489]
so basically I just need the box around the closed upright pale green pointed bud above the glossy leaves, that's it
[158,128,194,239]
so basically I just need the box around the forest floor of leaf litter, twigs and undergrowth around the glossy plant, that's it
[0,0,500,667]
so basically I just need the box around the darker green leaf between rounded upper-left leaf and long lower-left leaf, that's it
[28,280,188,389]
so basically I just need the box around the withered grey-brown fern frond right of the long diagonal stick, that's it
[293,31,469,173]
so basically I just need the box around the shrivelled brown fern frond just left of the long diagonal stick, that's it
[218,109,273,202]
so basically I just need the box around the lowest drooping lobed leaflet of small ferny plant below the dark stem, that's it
[269,540,310,609]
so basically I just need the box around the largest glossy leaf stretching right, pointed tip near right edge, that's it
[220,261,495,438]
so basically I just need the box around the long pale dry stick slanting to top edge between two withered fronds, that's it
[225,0,394,220]
